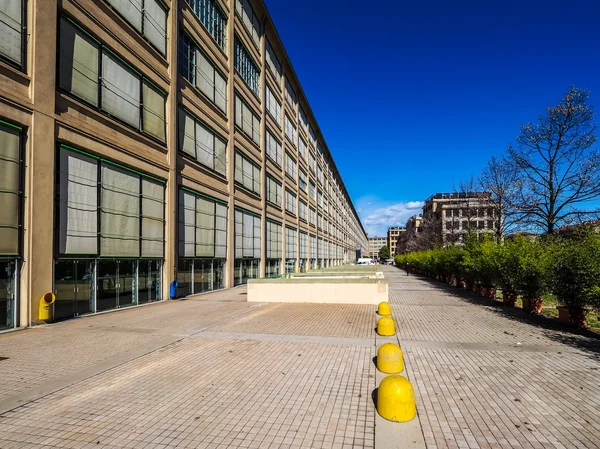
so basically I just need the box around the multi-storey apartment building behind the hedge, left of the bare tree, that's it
[423,192,502,244]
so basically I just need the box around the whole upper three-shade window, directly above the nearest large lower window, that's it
[58,17,166,142]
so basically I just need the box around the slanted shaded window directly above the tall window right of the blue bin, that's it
[178,108,227,176]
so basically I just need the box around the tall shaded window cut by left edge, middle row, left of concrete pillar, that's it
[0,122,21,256]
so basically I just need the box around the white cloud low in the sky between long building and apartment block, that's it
[358,201,423,237]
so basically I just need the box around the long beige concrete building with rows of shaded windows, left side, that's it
[0,0,368,328]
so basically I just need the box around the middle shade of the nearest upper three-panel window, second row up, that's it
[102,51,140,128]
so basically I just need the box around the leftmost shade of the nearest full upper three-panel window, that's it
[59,18,99,106]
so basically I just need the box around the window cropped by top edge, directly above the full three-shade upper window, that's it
[107,0,167,55]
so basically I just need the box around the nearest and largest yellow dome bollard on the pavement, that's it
[377,375,417,422]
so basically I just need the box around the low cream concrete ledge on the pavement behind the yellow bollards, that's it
[248,277,388,305]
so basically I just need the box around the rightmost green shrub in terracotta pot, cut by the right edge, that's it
[551,231,600,327]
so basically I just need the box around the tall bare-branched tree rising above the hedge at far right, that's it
[508,87,600,234]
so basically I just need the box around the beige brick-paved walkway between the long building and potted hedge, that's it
[0,267,600,449]
